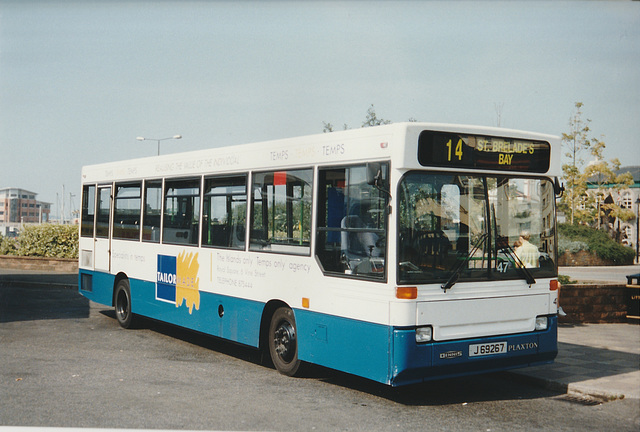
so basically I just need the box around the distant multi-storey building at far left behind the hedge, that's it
[0,188,51,236]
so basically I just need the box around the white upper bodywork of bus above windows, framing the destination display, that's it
[82,122,560,183]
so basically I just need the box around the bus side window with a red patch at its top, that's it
[249,169,313,255]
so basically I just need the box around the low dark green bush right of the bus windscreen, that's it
[558,224,635,265]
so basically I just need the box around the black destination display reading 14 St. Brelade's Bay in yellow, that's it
[418,131,551,173]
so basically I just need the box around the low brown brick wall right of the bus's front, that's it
[558,285,627,323]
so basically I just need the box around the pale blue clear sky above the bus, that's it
[0,0,640,218]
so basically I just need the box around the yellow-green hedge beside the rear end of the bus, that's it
[17,224,78,258]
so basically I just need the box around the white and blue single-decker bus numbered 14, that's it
[79,122,562,386]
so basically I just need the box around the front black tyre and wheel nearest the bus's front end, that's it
[269,307,300,376]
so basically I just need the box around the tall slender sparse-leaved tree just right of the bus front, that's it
[561,102,591,225]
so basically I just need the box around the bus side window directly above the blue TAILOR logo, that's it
[162,179,200,245]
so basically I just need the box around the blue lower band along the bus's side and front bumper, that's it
[80,270,557,386]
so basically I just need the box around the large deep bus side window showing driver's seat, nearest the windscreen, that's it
[316,164,388,279]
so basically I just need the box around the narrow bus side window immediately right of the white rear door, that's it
[113,183,141,240]
